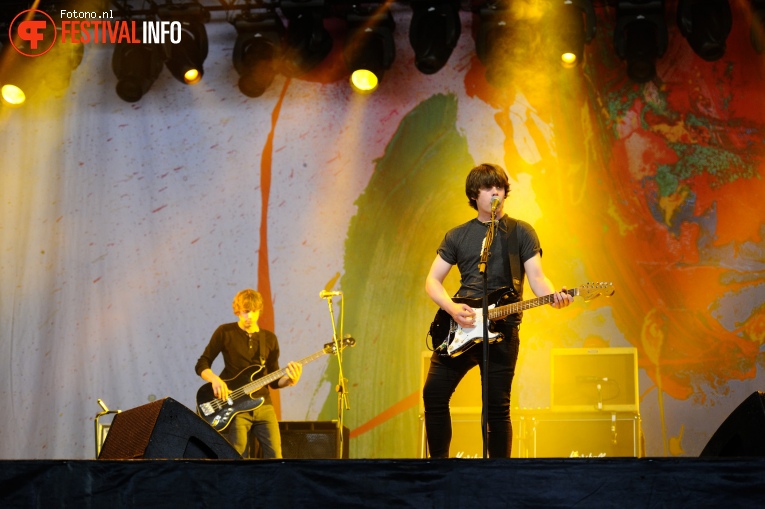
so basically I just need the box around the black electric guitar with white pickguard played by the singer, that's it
[430,283,616,357]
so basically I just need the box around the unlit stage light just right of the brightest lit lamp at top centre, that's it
[409,0,462,74]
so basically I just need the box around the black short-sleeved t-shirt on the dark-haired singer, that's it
[437,216,542,318]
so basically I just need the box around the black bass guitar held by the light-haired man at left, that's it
[197,337,356,431]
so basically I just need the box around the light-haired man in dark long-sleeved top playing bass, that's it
[195,289,303,459]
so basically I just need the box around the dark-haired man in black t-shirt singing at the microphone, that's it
[423,164,573,458]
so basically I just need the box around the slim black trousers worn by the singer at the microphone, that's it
[422,324,520,458]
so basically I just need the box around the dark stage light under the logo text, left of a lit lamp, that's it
[112,34,168,103]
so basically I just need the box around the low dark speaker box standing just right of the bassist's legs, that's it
[279,421,350,459]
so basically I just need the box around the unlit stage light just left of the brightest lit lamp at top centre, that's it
[281,0,332,77]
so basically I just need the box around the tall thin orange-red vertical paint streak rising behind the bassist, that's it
[258,78,290,419]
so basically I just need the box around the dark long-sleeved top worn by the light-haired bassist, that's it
[195,322,279,403]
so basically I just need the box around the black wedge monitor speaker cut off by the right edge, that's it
[700,391,765,458]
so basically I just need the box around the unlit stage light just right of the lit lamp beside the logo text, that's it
[233,11,284,97]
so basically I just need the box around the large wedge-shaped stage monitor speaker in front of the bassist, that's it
[98,398,242,460]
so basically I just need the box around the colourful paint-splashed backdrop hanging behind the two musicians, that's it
[0,2,765,458]
